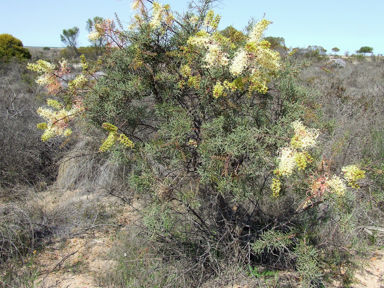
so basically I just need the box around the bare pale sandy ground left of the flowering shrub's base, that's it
[30,191,140,288]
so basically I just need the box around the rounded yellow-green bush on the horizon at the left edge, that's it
[0,34,32,62]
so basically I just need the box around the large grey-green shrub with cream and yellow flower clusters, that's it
[30,0,378,286]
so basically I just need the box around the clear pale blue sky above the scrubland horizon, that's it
[0,0,384,55]
